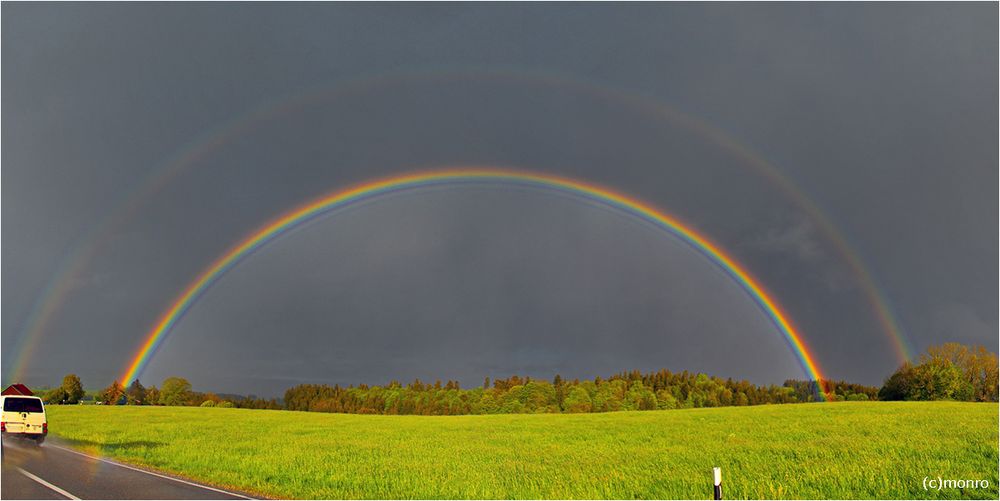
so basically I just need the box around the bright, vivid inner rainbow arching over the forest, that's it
[121,168,824,396]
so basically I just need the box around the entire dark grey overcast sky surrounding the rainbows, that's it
[2,3,998,396]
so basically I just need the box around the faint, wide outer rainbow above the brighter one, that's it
[4,67,914,381]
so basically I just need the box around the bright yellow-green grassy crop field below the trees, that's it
[48,402,1000,499]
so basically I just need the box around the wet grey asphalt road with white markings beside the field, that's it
[0,438,250,499]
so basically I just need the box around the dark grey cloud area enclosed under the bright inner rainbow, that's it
[143,188,798,392]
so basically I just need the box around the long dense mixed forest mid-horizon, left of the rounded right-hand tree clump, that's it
[285,370,878,415]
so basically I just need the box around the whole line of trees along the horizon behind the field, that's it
[44,343,998,415]
